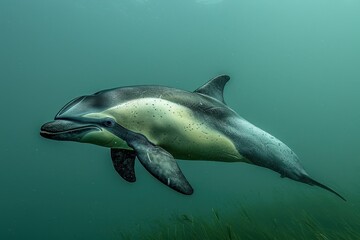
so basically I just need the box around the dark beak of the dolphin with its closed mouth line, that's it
[40,119,102,141]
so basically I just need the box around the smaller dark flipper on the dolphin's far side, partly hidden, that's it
[111,148,136,182]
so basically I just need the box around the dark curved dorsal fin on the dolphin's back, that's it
[194,75,230,104]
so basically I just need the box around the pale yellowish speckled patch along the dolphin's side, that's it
[100,98,243,161]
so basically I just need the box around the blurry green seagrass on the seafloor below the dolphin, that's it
[120,198,360,240]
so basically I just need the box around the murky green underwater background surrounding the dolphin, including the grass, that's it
[0,0,360,240]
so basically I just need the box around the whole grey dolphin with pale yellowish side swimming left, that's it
[40,75,346,201]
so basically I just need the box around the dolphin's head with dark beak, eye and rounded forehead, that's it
[40,93,129,148]
